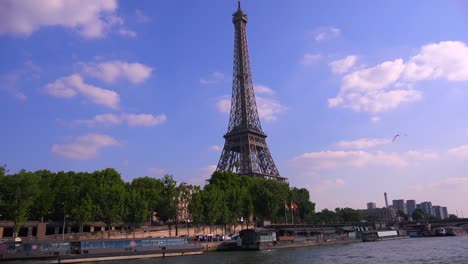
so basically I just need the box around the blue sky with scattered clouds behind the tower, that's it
[0,0,468,216]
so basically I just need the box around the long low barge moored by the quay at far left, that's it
[0,238,203,263]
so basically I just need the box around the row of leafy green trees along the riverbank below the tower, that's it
[0,166,370,237]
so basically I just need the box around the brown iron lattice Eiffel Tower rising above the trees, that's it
[216,1,287,182]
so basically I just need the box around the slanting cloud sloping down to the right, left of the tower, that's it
[45,74,120,109]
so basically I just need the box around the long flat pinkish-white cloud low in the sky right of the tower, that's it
[291,150,439,171]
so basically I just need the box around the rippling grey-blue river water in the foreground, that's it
[109,236,468,264]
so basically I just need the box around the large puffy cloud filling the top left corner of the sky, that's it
[0,0,123,38]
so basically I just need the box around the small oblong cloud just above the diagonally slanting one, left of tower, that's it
[82,60,153,83]
